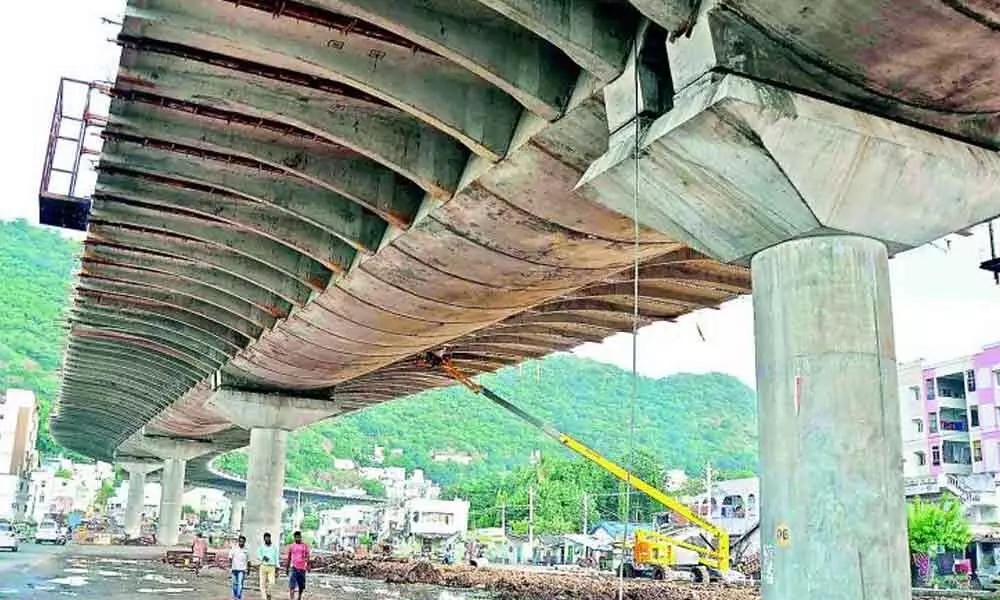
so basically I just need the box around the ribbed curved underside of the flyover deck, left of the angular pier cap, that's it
[52,0,749,458]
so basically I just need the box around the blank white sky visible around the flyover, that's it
[0,0,1000,385]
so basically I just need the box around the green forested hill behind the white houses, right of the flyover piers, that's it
[215,354,757,485]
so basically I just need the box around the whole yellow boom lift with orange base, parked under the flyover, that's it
[420,352,731,581]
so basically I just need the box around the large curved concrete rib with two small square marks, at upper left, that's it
[122,0,522,161]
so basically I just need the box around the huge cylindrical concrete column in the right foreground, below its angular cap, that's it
[751,236,910,600]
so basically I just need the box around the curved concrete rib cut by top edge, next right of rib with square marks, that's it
[300,0,578,121]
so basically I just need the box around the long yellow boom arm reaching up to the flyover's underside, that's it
[422,352,730,571]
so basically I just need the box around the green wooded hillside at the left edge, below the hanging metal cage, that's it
[0,220,80,453]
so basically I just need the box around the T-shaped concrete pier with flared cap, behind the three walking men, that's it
[209,388,340,556]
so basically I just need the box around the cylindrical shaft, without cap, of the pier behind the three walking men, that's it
[243,427,288,556]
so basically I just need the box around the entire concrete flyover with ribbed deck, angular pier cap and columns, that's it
[52,0,1000,600]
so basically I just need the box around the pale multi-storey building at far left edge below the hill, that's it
[0,389,38,518]
